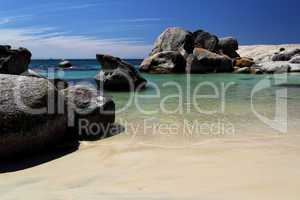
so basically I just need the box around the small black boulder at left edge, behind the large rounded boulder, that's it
[0,46,31,75]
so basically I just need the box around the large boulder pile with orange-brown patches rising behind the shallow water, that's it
[140,28,239,74]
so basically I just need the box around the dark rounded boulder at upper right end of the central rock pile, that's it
[219,37,240,58]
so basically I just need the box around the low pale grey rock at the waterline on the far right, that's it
[258,61,291,74]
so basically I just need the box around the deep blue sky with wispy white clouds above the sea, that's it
[0,0,300,59]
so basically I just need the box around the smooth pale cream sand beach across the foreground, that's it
[0,132,300,200]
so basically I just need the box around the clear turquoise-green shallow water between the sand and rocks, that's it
[31,60,300,143]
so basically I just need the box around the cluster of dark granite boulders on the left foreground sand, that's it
[0,46,115,160]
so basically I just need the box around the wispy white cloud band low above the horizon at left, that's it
[0,27,152,58]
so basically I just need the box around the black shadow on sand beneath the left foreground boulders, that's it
[0,124,125,173]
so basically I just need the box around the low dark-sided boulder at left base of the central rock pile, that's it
[140,51,186,74]
